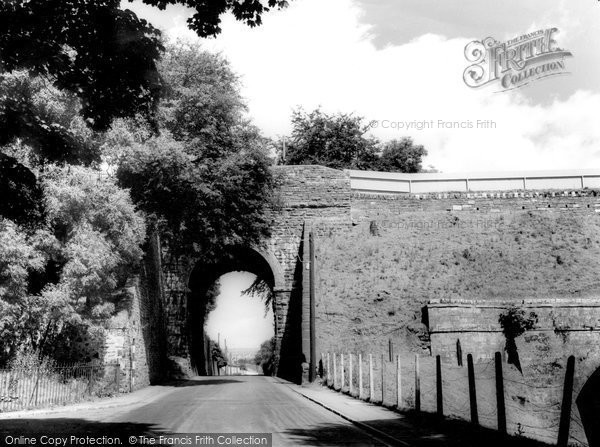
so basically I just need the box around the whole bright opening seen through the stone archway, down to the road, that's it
[205,272,275,375]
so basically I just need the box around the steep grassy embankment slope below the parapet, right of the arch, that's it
[316,210,600,351]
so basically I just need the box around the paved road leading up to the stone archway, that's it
[0,376,384,446]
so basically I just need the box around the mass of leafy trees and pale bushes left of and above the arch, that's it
[0,45,273,372]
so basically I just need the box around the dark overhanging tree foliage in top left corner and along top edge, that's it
[0,0,287,229]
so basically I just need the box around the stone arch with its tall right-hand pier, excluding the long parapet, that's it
[161,166,351,381]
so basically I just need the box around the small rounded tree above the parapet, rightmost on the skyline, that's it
[375,137,427,173]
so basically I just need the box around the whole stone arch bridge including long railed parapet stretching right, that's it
[155,165,600,381]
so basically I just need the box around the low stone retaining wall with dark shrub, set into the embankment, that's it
[427,297,600,364]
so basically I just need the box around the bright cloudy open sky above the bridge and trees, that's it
[125,0,600,172]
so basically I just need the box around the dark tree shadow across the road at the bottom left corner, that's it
[0,418,170,445]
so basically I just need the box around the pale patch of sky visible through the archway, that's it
[206,272,274,350]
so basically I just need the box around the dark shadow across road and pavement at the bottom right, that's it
[286,414,549,447]
